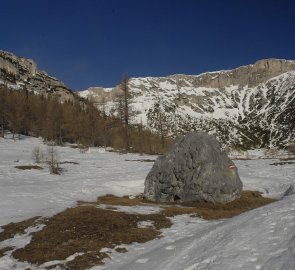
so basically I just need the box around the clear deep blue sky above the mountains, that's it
[0,0,295,90]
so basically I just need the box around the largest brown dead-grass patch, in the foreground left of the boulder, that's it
[12,205,171,270]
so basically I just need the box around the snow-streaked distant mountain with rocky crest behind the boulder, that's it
[80,59,295,149]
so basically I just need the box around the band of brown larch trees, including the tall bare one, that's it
[0,82,172,154]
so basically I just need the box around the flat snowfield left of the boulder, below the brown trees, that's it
[0,137,155,226]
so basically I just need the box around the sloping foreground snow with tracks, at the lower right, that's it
[100,195,295,270]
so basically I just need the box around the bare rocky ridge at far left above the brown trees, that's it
[0,51,74,102]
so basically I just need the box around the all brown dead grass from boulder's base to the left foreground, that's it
[0,191,274,270]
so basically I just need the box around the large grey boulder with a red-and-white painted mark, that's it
[144,132,243,203]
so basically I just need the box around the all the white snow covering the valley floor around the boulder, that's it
[0,137,295,270]
